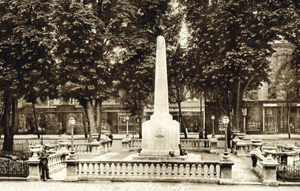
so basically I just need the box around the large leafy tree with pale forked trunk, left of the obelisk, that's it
[54,0,140,140]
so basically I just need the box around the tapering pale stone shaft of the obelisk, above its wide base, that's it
[153,36,170,117]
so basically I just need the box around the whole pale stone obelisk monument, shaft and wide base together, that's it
[140,36,180,156]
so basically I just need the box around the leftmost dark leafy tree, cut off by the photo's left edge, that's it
[0,0,53,151]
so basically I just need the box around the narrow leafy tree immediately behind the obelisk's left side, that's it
[114,0,176,137]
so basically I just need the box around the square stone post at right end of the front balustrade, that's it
[219,160,234,184]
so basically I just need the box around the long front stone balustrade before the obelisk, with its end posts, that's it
[65,160,233,183]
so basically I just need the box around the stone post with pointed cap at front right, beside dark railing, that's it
[262,156,279,186]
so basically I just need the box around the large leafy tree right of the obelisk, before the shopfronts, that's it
[185,0,290,136]
